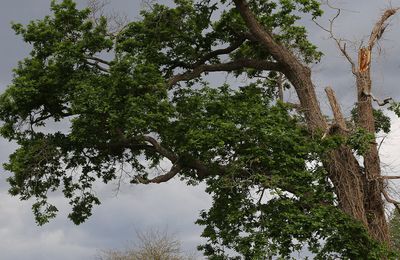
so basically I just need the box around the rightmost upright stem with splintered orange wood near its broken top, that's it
[355,5,399,245]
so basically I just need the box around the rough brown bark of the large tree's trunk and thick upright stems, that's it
[234,0,397,246]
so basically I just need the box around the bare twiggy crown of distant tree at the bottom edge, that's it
[94,230,193,260]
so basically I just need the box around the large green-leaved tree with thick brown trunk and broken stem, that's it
[0,0,400,259]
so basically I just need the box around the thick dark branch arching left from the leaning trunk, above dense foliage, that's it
[167,59,282,87]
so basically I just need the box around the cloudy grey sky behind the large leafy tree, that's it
[0,0,400,260]
